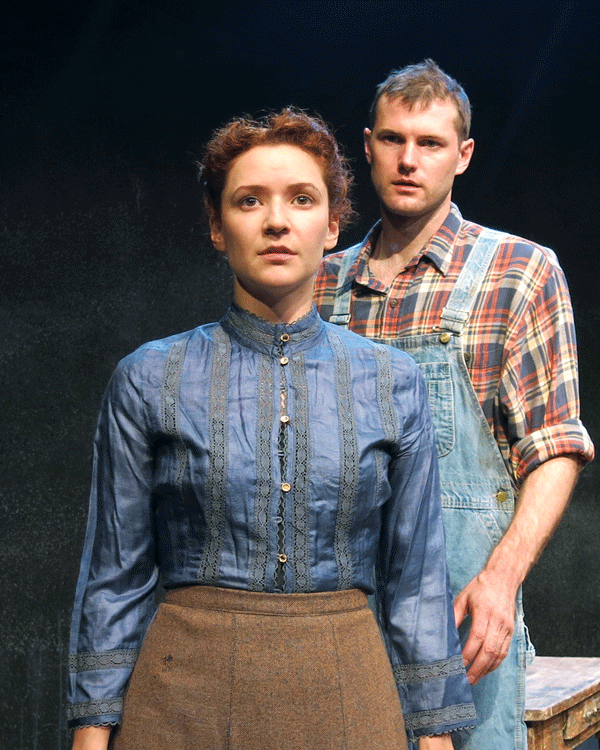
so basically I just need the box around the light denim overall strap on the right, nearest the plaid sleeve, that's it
[440,228,508,335]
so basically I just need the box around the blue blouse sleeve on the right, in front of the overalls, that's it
[377,362,478,738]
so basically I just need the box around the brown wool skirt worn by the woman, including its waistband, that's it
[111,586,407,750]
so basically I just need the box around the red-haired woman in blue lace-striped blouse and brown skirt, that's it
[69,109,475,750]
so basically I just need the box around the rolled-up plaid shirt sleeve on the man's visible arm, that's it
[499,248,594,486]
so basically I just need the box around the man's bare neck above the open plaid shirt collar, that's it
[369,200,450,286]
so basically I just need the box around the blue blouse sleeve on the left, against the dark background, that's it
[67,355,157,727]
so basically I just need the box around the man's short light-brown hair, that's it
[370,58,471,143]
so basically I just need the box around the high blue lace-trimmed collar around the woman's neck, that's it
[221,302,325,354]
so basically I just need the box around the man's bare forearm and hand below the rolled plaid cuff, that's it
[454,456,581,685]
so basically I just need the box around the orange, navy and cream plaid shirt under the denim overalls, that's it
[315,204,594,487]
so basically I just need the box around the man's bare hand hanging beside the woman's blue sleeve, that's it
[454,570,517,685]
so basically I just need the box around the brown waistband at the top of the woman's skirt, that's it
[164,586,368,617]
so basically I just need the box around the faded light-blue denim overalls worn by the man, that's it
[330,229,532,750]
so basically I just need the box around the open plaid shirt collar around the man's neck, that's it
[351,203,463,291]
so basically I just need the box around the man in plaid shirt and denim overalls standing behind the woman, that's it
[316,60,594,750]
